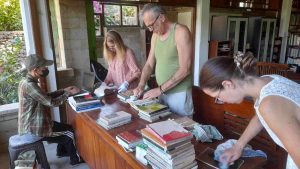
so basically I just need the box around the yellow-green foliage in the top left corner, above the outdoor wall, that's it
[0,0,23,31]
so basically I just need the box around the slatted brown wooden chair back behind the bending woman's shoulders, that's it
[256,62,289,77]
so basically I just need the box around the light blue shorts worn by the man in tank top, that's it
[160,89,194,117]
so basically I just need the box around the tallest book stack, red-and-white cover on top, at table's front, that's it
[141,120,198,169]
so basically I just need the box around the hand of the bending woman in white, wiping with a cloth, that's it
[220,144,243,164]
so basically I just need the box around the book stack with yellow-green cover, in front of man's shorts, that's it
[129,99,172,122]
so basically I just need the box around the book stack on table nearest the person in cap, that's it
[68,93,103,113]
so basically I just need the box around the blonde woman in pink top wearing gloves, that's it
[103,30,141,93]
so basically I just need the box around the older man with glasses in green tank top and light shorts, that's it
[134,4,193,116]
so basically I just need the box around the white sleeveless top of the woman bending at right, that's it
[254,75,300,169]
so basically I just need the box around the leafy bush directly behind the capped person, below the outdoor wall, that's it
[0,38,24,105]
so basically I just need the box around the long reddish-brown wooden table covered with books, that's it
[66,95,265,169]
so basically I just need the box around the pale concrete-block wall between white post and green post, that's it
[54,0,90,87]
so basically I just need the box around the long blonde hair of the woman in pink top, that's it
[103,30,127,62]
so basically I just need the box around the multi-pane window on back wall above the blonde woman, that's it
[93,1,139,36]
